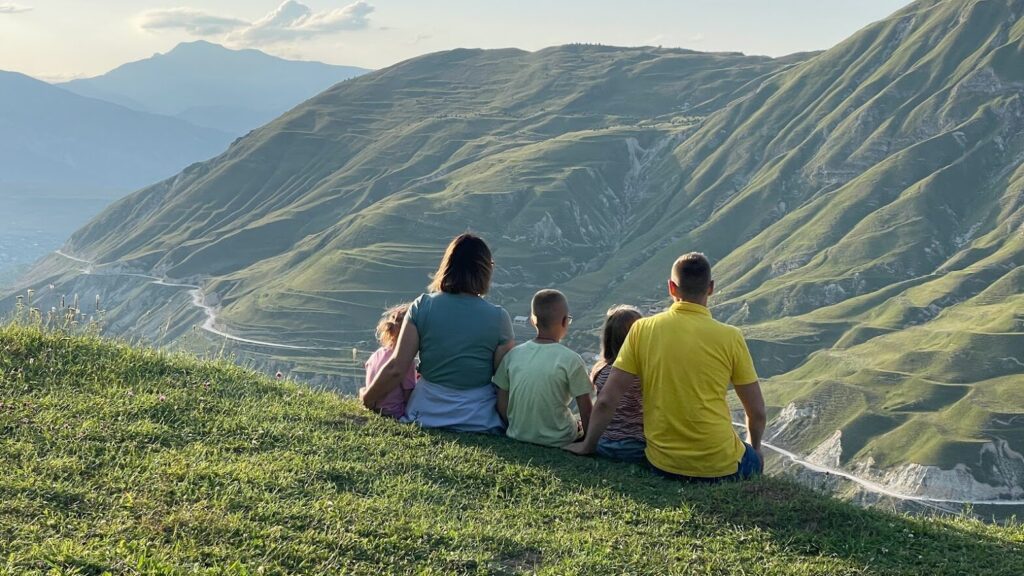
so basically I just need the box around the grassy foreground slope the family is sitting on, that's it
[0,326,1024,575]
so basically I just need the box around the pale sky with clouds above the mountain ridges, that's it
[0,0,907,81]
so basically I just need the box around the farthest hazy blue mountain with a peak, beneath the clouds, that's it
[60,41,368,135]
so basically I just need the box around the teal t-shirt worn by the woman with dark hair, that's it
[409,292,514,389]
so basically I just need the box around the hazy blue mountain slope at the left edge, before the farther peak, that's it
[0,72,231,192]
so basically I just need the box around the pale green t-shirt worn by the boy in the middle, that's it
[495,340,594,447]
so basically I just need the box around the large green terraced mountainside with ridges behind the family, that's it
[9,0,1024,498]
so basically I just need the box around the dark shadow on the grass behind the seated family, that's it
[444,431,1024,574]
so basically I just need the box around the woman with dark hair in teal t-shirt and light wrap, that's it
[361,234,515,433]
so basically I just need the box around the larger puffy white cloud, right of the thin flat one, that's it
[227,0,374,45]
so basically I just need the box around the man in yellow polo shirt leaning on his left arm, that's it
[566,252,767,482]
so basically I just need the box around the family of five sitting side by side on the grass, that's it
[359,234,766,482]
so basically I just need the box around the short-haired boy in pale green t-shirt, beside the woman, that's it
[495,290,594,448]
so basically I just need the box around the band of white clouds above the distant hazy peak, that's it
[137,0,374,46]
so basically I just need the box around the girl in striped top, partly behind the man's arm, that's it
[591,305,647,462]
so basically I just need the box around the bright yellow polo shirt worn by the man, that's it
[614,302,758,478]
